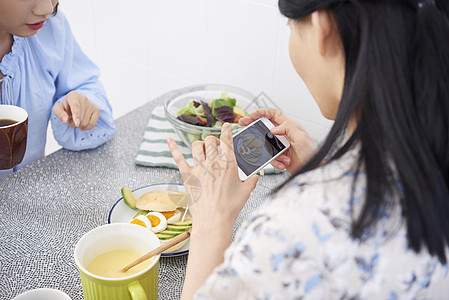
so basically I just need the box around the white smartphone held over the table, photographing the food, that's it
[233,118,290,181]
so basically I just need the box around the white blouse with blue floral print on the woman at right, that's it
[195,150,449,300]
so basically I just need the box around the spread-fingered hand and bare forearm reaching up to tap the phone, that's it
[167,124,259,300]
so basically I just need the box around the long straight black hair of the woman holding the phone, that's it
[279,0,449,263]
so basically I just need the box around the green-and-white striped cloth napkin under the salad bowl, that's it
[135,106,280,174]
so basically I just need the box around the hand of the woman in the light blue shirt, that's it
[53,91,100,130]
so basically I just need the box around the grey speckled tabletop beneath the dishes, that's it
[0,96,285,300]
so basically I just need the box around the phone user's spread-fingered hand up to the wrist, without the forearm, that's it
[167,124,259,235]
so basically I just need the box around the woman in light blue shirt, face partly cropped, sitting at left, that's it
[0,0,115,178]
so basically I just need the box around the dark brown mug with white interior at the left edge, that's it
[0,105,28,170]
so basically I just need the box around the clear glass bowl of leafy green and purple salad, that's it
[164,84,261,147]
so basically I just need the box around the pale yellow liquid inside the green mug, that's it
[86,250,154,278]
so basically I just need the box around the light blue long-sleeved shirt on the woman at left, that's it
[0,11,115,178]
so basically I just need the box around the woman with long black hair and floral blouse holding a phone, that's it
[168,0,449,299]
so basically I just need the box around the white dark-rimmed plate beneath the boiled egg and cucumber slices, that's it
[108,183,190,257]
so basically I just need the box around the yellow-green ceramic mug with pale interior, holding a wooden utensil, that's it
[74,223,160,300]
